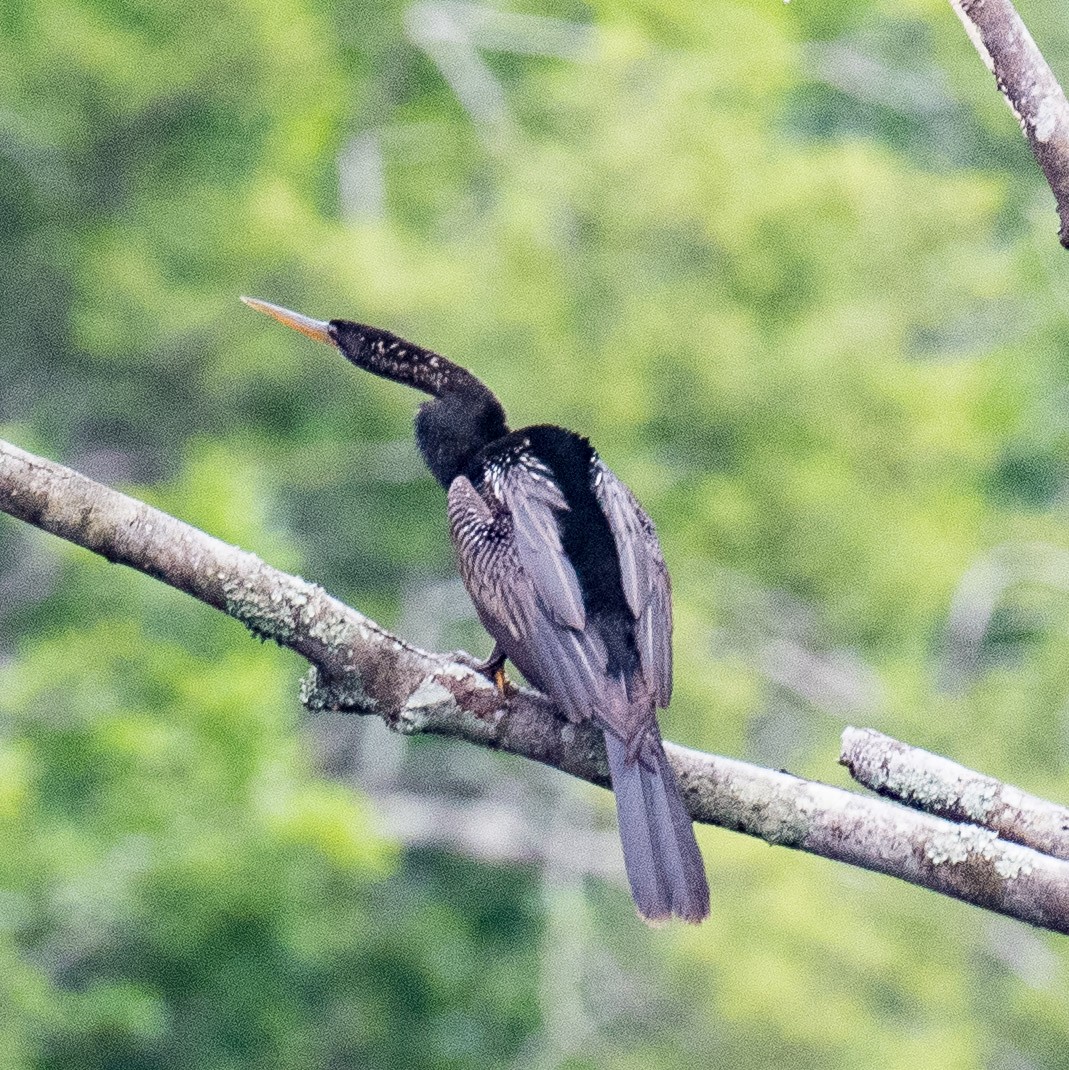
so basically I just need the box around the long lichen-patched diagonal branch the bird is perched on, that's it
[0,442,1069,933]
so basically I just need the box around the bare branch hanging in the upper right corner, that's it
[950,0,1069,248]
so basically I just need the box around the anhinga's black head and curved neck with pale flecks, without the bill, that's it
[329,320,508,487]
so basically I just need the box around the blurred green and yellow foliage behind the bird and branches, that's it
[0,0,1069,1070]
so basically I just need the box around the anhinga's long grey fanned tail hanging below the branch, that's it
[605,730,709,923]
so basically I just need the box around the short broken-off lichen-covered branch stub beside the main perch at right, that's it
[839,728,1069,861]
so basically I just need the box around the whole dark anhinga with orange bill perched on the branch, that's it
[243,297,709,922]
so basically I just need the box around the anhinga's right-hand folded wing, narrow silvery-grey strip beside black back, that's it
[593,459,672,707]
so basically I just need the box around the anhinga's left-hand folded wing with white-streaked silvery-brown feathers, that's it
[449,465,627,732]
